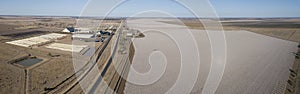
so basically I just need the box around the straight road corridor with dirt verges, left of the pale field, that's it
[64,22,130,94]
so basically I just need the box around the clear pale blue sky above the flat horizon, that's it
[0,0,300,17]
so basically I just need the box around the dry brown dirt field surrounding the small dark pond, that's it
[0,36,74,93]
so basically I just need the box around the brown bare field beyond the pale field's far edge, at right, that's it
[164,18,300,42]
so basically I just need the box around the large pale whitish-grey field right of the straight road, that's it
[125,19,298,94]
